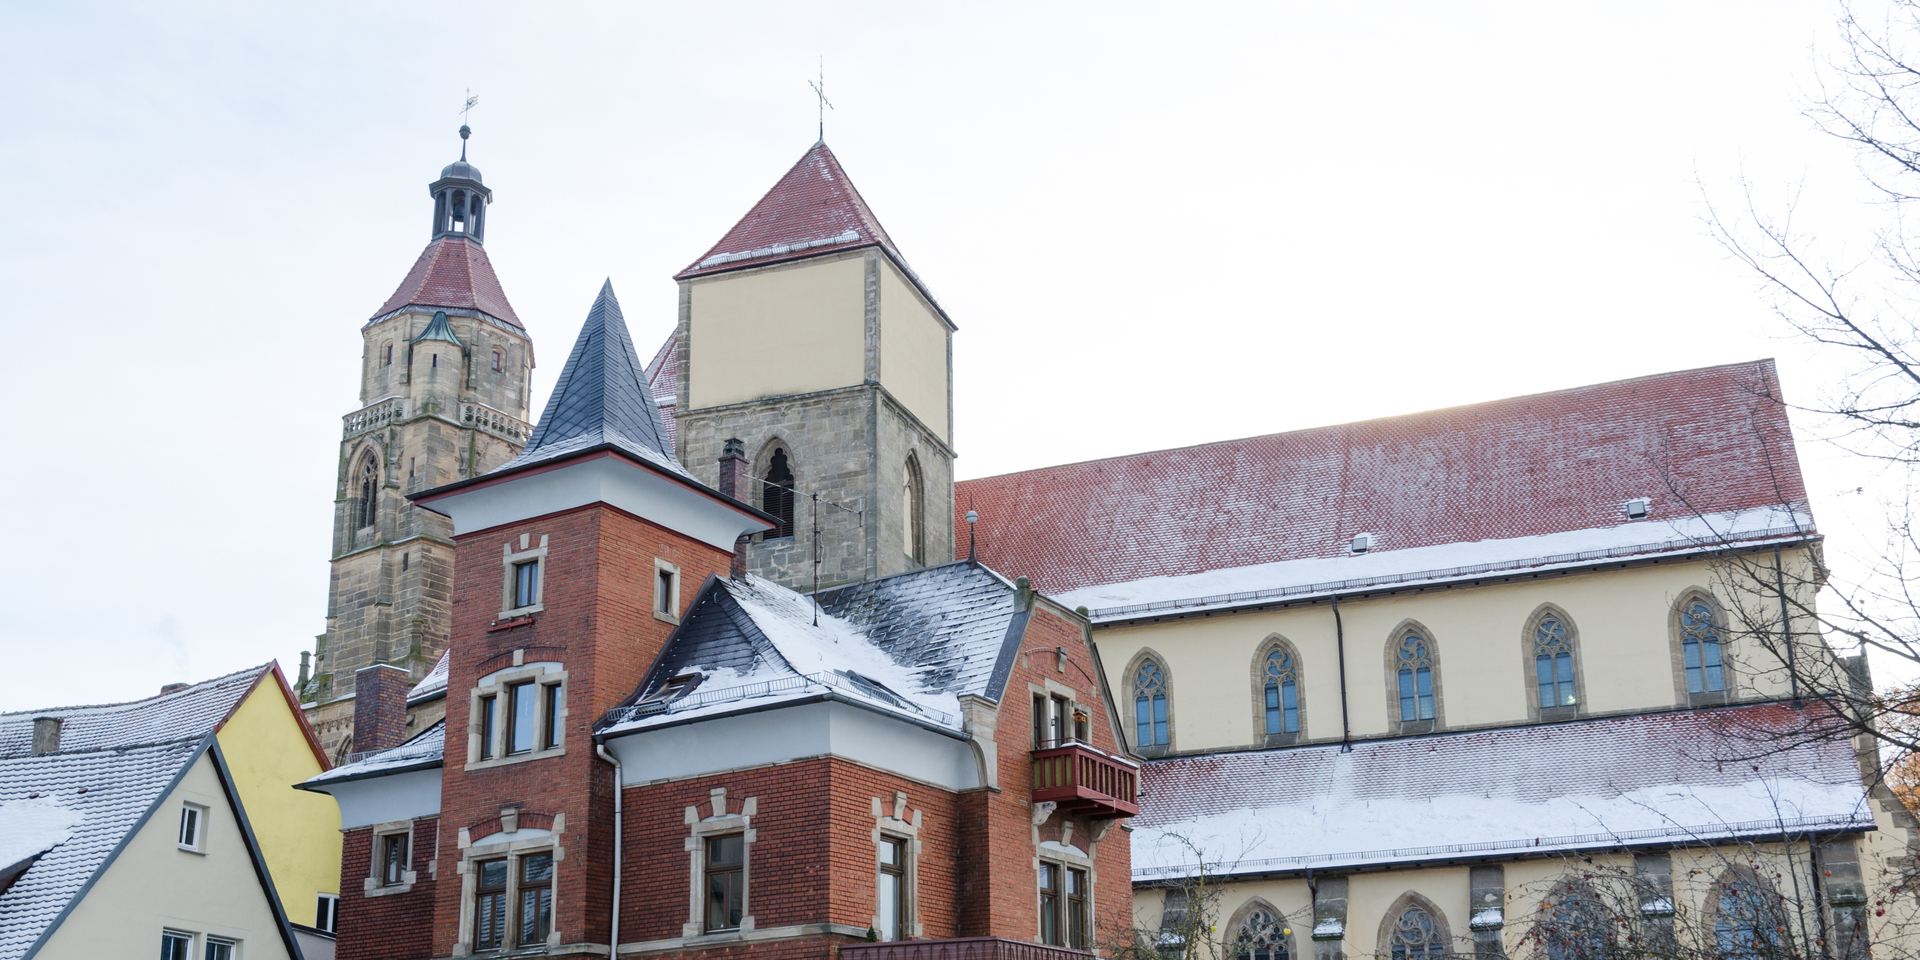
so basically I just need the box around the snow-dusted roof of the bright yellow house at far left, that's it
[0,662,273,758]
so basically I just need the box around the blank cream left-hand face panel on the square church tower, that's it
[680,255,867,408]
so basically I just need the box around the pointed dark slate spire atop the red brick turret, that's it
[501,280,691,476]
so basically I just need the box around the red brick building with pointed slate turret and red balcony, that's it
[305,274,1137,960]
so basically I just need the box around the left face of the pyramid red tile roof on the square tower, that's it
[674,144,899,280]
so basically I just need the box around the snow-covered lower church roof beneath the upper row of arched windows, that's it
[1133,705,1874,879]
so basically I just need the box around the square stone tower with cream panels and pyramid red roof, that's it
[664,142,954,589]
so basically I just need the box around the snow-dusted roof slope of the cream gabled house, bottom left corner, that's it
[0,737,205,960]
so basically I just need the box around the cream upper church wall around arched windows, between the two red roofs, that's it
[1094,563,1812,753]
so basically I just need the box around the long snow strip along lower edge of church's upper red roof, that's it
[1054,507,1812,622]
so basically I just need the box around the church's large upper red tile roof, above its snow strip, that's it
[954,361,1807,593]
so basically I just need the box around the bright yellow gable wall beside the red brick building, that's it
[219,678,340,925]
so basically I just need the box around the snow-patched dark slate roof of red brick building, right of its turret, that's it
[601,561,1025,733]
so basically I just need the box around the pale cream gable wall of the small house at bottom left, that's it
[38,755,293,960]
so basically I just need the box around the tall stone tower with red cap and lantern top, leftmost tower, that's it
[301,127,534,758]
